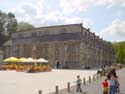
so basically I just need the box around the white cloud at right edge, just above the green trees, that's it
[99,19,125,41]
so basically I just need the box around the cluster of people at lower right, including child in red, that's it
[102,64,120,94]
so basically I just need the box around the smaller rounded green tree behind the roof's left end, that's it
[18,22,34,31]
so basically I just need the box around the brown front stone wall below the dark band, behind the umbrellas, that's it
[10,40,80,68]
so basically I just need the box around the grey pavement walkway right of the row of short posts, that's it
[50,68,125,94]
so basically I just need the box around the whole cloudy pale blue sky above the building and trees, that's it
[0,0,125,42]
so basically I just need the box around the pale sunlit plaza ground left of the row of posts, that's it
[0,69,96,94]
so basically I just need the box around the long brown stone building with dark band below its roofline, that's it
[1,24,116,68]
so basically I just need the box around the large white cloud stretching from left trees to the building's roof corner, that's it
[6,0,93,27]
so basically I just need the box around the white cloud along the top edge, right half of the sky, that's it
[59,0,125,14]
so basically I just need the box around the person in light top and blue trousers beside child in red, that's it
[109,74,116,94]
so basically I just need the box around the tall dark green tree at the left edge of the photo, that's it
[0,11,17,46]
